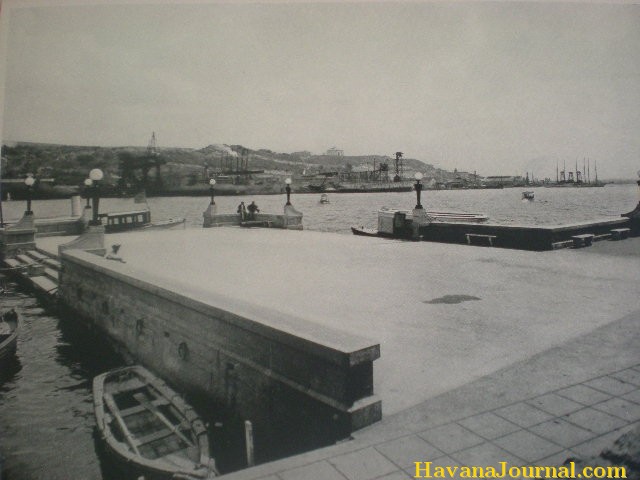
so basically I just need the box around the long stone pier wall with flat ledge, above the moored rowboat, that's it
[59,250,381,446]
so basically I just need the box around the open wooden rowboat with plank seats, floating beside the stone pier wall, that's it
[93,366,218,480]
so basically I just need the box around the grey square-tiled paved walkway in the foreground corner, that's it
[224,310,640,480]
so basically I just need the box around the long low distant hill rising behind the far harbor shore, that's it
[2,142,470,186]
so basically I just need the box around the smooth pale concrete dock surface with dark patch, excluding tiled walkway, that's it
[38,229,640,414]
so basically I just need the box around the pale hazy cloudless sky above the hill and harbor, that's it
[2,0,640,179]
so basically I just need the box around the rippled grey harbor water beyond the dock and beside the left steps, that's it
[0,185,638,480]
